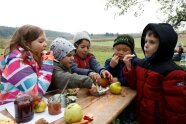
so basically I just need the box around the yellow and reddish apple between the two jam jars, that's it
[34,100,47,112]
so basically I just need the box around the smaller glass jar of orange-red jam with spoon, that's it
[48,96,62,115]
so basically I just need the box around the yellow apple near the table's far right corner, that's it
[109,81,122,95]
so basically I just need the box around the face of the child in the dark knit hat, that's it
[113,44,132,60]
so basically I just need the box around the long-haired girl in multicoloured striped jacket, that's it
[0,25,54,104]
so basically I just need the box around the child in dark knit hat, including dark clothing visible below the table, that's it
[105,34,135,124]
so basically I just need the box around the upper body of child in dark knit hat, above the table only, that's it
[105,34,135,86]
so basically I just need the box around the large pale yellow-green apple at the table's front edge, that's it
[64,103,83,124]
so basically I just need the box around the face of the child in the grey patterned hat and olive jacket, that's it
[60,51,74,68]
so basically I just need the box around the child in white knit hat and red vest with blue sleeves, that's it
[72,32,112,81]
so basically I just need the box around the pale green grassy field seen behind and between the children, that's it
[0,34,186,65]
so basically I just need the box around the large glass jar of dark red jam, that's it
[14,94,34,123]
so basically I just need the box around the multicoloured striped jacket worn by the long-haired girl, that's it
[2,58,53,98]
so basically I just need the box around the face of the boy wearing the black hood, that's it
[144,35,159,58]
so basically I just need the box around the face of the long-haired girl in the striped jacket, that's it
[26,34,47,57]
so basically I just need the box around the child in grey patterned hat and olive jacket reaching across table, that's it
[49,37,93,90]
